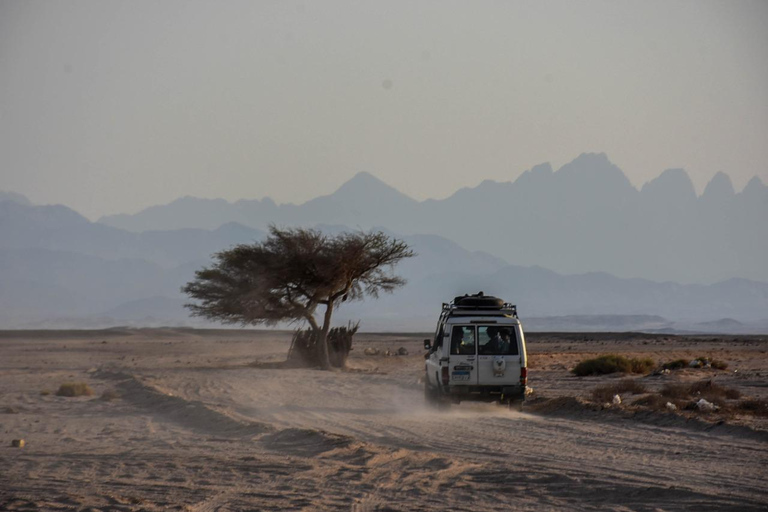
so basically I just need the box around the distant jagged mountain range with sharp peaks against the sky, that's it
[99,153,768,283]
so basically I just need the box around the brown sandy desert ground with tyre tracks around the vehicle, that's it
[0,329,768,511]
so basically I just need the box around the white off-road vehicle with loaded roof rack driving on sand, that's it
[424,292,528,409]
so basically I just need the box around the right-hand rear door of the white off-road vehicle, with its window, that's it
[476,324,521,386]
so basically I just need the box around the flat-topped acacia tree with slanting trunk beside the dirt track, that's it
[182,226,414,369]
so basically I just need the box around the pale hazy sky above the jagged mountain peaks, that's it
[0,0,768,218]
